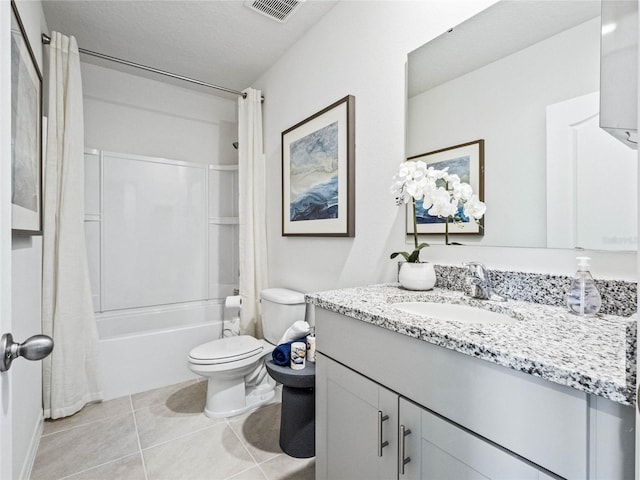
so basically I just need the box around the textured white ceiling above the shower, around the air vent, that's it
[42,0,337,96]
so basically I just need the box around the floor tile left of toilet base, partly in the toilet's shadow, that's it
[134,383,224,449]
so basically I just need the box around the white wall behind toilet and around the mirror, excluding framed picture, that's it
[255,0,636,291]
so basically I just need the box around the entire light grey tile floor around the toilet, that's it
[31,380,315,480]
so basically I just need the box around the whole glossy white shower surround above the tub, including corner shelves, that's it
[85,150,238,312]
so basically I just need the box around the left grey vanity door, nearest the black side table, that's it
[316,354,398,480]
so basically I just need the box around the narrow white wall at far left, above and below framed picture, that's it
[8,0,48,478]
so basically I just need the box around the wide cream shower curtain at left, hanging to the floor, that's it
[42,32,102,418]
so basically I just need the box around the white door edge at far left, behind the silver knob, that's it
[0,1,13,479]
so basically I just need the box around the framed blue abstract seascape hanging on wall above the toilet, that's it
[282,95,355,237]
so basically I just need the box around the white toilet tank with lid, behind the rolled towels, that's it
[260,288,306,345]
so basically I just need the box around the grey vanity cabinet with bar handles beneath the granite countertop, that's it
[315,307,634,480]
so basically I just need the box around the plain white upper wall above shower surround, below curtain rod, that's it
[81,62,238,164]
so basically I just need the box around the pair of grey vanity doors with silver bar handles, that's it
[316,354,552,480]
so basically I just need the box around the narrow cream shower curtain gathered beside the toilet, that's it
[238,88,268,337]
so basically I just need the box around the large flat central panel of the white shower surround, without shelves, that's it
[102,153,207,310]
